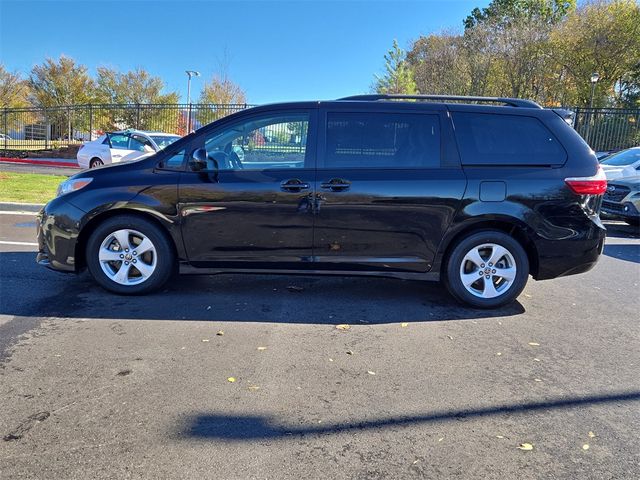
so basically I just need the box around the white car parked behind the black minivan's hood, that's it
[77,130,180,168]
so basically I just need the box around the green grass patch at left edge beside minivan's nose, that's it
[0,172,67,203]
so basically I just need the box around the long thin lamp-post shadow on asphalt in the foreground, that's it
[178,392,640,441]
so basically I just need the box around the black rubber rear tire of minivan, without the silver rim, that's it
[443,230,529,308]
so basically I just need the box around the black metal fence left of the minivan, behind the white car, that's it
[0,104,252,150]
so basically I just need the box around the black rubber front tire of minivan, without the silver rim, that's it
[86,214,176,295]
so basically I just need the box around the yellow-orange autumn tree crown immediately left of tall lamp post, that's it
[96,67,179,104]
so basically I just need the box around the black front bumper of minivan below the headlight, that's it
[36,198,85,272]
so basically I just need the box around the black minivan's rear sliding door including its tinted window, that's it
[314,105,466,272]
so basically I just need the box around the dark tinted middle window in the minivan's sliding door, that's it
[324,113,440,168]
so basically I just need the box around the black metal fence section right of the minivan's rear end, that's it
[571,108,640,151]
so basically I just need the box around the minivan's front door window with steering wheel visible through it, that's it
[204,113,309,170]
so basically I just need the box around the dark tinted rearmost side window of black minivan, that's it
[453,112,566,165]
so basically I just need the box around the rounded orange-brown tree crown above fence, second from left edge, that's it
[27,55,95,107]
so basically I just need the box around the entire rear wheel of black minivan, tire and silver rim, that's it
[445,230,529,308]
